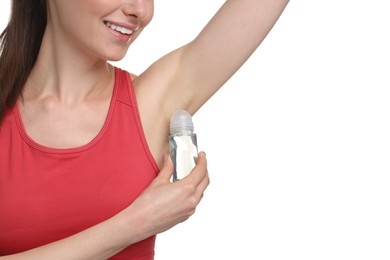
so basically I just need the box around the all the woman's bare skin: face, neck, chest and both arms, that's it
[0,0,288,259]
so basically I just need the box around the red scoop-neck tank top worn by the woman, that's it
[0,68,159,260]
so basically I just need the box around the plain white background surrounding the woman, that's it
[0,0,390,260]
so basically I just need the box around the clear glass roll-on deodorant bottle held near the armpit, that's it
[169,110,198,181]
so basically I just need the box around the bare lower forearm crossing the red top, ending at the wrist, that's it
[0,209,143,260]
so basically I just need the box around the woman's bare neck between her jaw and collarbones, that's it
[23,24,114,103]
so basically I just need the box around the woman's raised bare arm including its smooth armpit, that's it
[134,0,288,118]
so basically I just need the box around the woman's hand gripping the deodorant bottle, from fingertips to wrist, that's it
[128,152,209,238]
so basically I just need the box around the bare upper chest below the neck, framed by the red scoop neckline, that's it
[19,97,110,148]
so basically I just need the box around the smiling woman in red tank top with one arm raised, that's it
[0,0,288,260]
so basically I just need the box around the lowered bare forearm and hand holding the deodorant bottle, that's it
[0,153,209,260]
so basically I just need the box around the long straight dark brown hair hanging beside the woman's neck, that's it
[0,0,47,123]
